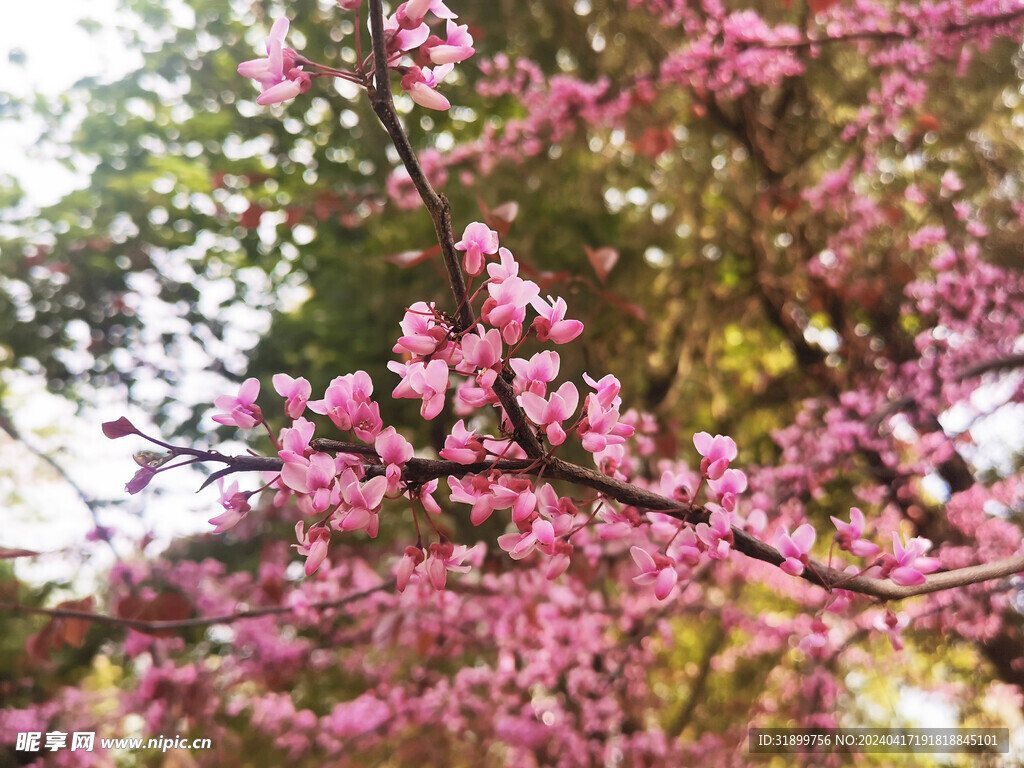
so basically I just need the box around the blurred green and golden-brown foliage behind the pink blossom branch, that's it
[0,0,1021,450]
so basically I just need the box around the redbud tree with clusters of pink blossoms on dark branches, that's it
[0,0,1024,765]
